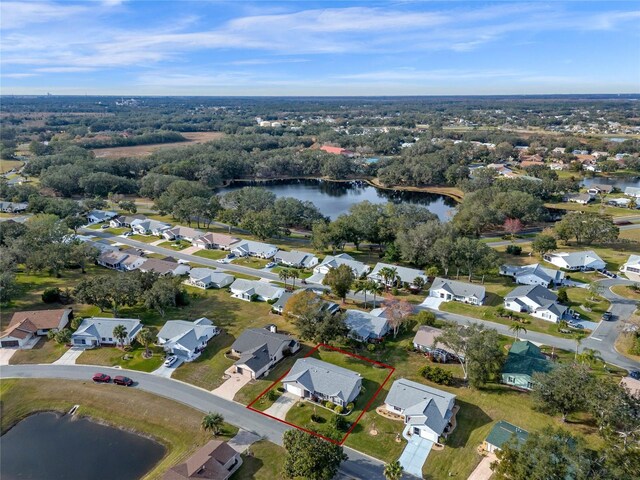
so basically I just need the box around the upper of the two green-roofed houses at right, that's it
[502,340,553,390]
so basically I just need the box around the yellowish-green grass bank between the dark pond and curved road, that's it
[0,379,237,479]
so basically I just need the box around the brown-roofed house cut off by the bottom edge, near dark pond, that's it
[162,440,242,480]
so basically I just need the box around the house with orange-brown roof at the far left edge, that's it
[0,308,72,348]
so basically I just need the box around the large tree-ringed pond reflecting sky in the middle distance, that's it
[219,180,456,221]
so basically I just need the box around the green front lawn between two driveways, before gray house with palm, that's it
[76,344,165,372]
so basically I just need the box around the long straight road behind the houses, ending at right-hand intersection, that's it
[83,229,640,370]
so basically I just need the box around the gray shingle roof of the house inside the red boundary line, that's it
[282,357,362,401]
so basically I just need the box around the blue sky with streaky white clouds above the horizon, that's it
[0,0,640,95]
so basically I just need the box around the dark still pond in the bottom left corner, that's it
[0,412,165,480]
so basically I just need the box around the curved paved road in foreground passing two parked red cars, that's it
[0,365,396,480]
